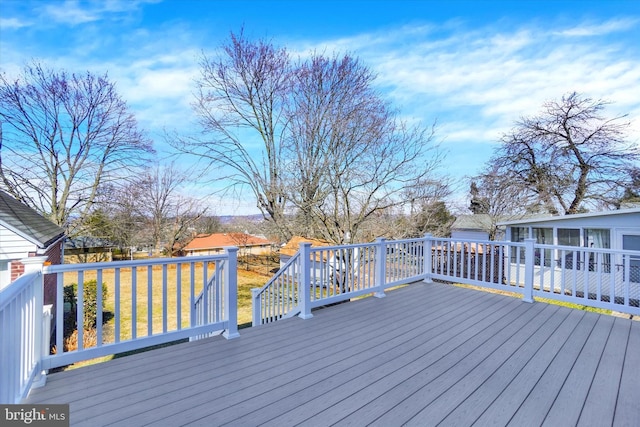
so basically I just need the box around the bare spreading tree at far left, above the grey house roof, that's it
[0,63,153,234]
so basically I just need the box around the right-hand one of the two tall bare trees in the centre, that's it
[286,55,442,243]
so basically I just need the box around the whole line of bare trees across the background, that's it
[0,31,640,253]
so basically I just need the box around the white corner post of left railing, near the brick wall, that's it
[20,256,49,388]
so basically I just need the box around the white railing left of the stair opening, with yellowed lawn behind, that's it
[0,248,238,403]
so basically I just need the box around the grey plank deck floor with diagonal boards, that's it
[22,283,640,426]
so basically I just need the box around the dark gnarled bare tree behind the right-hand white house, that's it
[492,92,640,214]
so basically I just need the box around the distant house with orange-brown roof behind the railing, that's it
[182,233,274,256]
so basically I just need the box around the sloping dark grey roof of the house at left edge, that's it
[0,190,64,249]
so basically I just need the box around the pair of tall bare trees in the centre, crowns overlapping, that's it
[176,34,437,242]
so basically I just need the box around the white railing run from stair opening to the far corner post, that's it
[252,239,425,326]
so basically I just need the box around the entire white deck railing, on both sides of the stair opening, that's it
[0,235,640,403]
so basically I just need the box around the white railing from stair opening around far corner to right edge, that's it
[253,235,640,325]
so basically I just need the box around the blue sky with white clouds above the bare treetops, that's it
[0,0,640,215]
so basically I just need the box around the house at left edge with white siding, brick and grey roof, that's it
[0,190,65,304]
